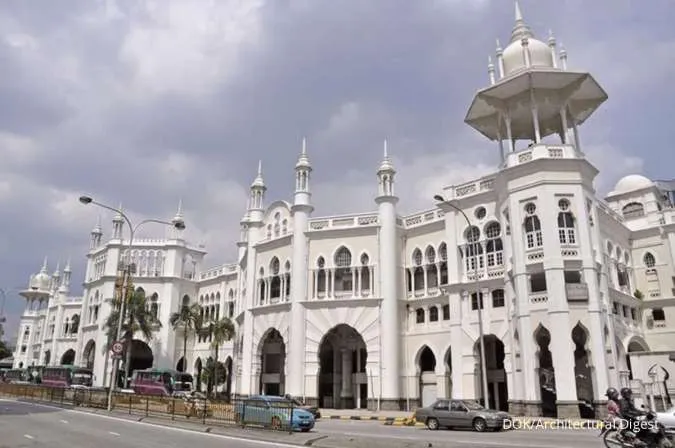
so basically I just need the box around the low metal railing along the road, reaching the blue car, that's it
[0,383,302,431]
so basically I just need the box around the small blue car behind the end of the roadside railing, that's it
[234,395,316,432]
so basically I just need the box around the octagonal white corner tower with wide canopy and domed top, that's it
[465,1,607,417]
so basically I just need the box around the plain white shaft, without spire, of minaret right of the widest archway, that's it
[376,196,401,406]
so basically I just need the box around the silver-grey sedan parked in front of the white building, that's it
[415,398,512,432]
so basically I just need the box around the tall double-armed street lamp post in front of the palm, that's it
[79,196,185,411]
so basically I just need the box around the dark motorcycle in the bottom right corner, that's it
[598,410,673,448]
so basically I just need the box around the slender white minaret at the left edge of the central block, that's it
[238,161,267,394]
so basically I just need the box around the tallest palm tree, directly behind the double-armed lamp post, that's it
[105,280,162,385]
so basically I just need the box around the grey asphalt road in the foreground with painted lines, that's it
[0,400,602,448]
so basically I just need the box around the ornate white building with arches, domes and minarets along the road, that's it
[10,3,675,416]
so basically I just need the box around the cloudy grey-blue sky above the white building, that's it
[0,0,675,342]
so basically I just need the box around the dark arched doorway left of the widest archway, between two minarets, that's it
[259,328,286,395]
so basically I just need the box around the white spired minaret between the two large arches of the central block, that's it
[287,138,314,397]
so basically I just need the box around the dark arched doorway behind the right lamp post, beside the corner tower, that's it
[474,334,509,412]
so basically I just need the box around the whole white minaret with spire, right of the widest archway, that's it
[375,140,402,409]
